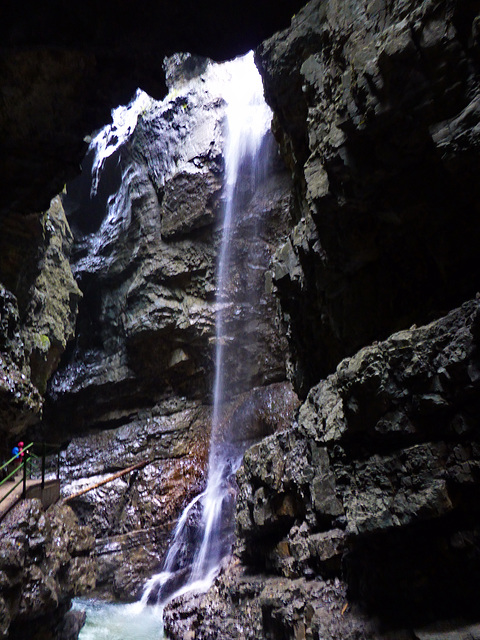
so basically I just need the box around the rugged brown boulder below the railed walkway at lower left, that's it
[0,500,95,640]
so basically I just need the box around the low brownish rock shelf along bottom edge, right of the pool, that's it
[164,562,386,640]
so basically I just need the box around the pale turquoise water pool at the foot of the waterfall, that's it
[73,598,165,640]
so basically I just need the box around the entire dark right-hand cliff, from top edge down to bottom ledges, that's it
[166,1,480,640]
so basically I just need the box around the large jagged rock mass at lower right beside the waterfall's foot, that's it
[169,300,480,639]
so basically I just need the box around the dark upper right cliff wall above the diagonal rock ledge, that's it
[257,0,480,395]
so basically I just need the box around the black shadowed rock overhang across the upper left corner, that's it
[0,0,305,215]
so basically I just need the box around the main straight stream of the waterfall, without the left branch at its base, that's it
[191,53,271,583]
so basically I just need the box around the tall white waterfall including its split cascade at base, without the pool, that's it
[142,52,271,605]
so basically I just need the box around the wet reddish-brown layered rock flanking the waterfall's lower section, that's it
[56,383,298,600]
